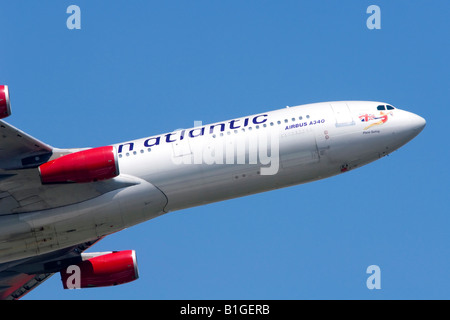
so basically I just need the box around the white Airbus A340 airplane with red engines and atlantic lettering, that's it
[0,85,426,300]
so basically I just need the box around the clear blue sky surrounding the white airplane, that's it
[0,0,450,299]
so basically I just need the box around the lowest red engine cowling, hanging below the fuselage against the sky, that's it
[60,250,139,289]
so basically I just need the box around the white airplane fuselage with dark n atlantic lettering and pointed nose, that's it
[0,101,425,262]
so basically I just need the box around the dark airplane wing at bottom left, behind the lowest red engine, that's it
[0,238,101,300]
